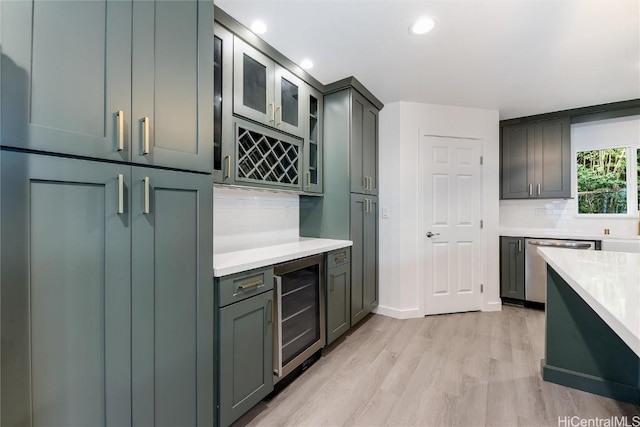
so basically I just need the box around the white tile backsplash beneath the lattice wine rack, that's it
[213,186,300,253]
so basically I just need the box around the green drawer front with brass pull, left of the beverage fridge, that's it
[216,267,273,307]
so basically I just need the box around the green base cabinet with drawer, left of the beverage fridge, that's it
[216,267,275,427]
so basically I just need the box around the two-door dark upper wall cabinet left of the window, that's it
[501,118,571,199]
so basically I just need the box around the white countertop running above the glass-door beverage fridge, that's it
[213,237,353,277]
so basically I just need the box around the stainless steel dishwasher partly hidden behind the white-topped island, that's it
[524,239,596,304]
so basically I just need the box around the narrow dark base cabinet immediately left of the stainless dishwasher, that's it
[500,236,525,301]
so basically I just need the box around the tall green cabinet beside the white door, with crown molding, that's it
[300,77,383,325]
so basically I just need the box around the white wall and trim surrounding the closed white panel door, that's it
[377,102,501,318]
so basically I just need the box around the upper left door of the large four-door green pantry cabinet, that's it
[1,0,131,161]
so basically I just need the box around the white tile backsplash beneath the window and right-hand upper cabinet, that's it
[500,199,638,236]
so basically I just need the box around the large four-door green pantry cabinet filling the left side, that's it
[0,0,216,426]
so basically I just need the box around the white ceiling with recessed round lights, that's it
[215,0,640,119]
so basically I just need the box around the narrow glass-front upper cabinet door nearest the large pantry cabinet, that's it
[213,23,234,183]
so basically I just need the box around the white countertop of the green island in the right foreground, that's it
[538,247,640,356]
